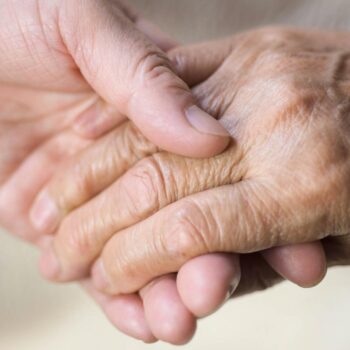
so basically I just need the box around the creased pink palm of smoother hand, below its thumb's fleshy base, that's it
[0,86,95,241]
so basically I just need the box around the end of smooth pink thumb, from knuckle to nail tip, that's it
[128,79,231,158]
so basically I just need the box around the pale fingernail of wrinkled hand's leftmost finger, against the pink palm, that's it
[30,192,60,234]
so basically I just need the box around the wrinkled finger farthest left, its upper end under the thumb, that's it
[30,123,157,233]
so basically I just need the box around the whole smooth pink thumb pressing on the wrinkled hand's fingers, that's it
[61,0,229,157]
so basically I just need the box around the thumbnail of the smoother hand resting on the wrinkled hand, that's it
[186,105,230,137]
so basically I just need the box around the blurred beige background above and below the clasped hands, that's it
[0,0,350,350]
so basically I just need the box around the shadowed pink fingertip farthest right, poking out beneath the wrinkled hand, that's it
[262,242,327,288]
